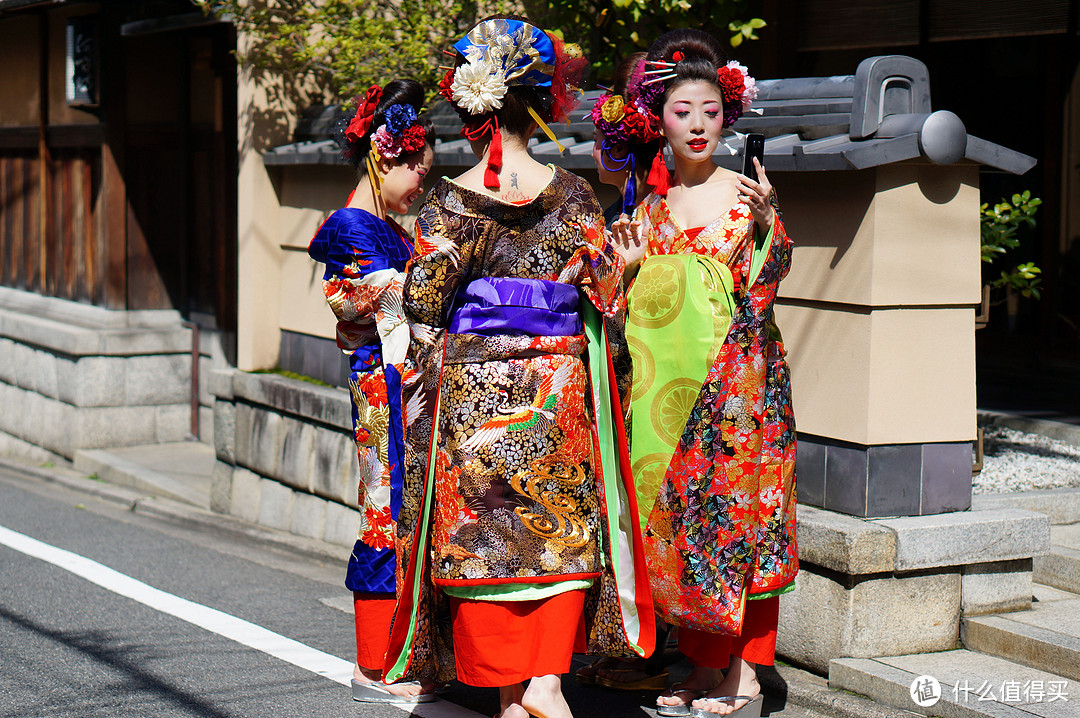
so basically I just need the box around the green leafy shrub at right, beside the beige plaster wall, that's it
[980,190,1042,301]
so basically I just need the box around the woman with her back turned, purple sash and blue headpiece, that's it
[387,16,653,718]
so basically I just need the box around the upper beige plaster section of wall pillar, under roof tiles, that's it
[777,163,982,307]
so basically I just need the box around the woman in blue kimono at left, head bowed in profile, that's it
[308,80,435,703]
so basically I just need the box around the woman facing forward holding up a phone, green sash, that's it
[624,30,798,716]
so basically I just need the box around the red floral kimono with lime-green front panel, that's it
[626,194,798,635]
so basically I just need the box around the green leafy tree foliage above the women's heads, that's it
[194,0,765,112]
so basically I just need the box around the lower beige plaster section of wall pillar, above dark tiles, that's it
[777,303,975,446]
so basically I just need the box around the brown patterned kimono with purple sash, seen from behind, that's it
[387,167,653,681]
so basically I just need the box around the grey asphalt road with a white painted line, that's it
[0,468,812,718]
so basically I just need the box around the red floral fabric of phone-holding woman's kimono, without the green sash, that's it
[636,194,798,633]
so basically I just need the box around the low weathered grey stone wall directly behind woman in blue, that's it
[211,369,360,547]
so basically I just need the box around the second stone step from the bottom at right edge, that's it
[960,578,1080,680]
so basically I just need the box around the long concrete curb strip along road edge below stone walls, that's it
[0,457,349,566]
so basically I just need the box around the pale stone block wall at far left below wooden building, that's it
[0,287,213,459]
